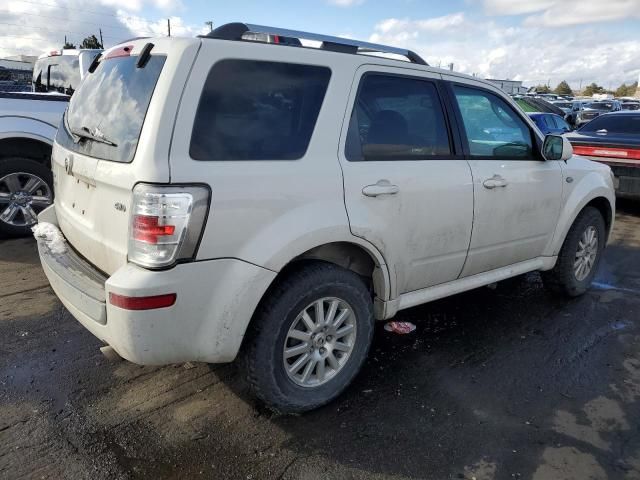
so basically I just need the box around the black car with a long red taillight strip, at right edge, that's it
[567,111,640,199]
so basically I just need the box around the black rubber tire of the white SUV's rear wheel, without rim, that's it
[241,262,374,413]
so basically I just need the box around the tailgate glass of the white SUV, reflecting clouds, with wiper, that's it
[56,55,166,162]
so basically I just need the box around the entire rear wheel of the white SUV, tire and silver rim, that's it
[243,262,374,413]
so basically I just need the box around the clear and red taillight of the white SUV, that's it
[128,184,210,268]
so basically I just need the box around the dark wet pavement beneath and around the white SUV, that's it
[0,204,640,480]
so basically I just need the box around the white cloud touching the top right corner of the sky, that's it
[483,0,640,27]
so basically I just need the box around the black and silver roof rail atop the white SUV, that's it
[199,23,428,65]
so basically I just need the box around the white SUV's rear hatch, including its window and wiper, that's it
[52,39,200,274]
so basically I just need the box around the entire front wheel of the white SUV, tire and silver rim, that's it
[542,207,606,297]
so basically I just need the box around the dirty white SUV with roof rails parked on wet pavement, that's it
[36,24,615,412]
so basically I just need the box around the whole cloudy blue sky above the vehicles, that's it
[0,0,640,88]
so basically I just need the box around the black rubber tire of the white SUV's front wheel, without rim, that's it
[542,207,606,297]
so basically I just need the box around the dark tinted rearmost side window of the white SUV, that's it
[189,60,331,161]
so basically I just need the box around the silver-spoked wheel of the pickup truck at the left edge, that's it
[0,157,53,236]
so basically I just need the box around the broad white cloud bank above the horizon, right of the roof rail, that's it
[369,14,640,88]
